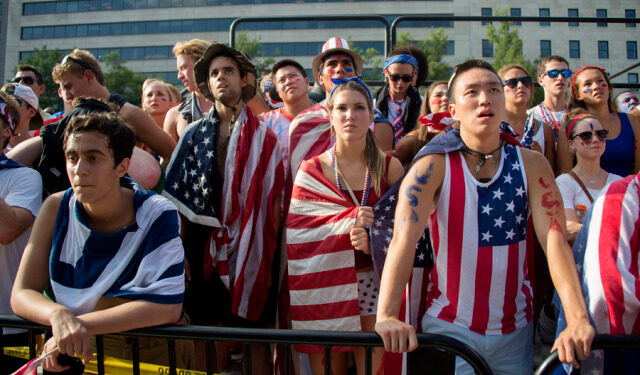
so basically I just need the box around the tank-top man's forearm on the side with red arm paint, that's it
[547,231,589,325]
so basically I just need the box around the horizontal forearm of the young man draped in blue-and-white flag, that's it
[78,301,182,335]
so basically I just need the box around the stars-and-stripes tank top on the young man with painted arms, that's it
[426,145,533,335]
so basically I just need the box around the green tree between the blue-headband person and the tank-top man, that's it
[396,29,451,80]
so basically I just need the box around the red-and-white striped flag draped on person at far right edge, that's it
[573,175,640,335]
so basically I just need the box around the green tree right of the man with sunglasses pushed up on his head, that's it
[101,52,145,106]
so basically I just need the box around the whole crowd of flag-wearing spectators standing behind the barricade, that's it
[0,33,640,374]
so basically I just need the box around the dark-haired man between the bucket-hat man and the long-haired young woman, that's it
[259,59,311,170]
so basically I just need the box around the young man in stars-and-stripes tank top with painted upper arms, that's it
[376,60,594,374]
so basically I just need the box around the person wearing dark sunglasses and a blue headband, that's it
[375,49,422,151]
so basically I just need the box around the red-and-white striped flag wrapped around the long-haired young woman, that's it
[286,161,361,352]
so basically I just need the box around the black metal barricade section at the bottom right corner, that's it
[536,335,640,375]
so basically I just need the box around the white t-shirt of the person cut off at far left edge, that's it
[0,168,42,333]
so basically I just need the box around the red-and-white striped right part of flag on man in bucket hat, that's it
[205,105,284,321]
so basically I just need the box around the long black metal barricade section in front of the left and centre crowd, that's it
[0,315,492,375]
